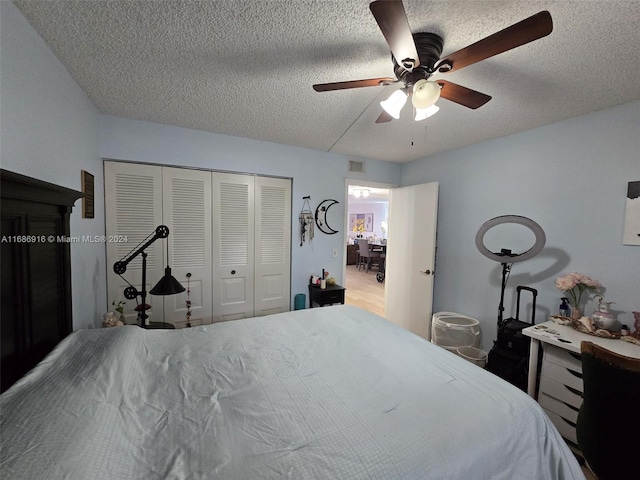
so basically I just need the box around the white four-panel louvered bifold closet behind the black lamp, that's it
[105,161,291,328]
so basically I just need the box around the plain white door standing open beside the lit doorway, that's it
[385,182,439,340]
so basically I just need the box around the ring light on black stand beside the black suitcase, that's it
[476,215,547,326]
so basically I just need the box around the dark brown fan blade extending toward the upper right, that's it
[436,11,553,72]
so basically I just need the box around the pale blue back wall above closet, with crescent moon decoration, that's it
[100,115,401,314]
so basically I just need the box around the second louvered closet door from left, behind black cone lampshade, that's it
[162,167,213,328]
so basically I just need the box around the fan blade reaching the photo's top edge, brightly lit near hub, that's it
[369,0,420,71]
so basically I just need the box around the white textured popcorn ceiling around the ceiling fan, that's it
[14,0,640,162]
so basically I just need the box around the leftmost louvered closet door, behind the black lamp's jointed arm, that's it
[104,162,163,324]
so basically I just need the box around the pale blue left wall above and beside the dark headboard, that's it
[0,1,106,328]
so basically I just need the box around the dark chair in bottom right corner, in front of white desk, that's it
[576,342,640,480]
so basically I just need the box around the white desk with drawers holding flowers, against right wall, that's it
[522,321,640,446]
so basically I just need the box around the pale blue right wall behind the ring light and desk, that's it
[401,102,640,348]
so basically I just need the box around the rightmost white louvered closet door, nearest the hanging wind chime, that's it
[255,177,291,316]
